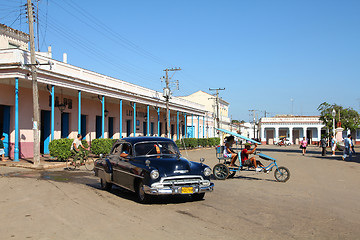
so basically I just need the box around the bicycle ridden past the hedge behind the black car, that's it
[66,150,95,171]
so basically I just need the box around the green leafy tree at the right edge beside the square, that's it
[317,102,360,132]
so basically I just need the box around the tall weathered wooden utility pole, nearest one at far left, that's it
[27,0,40,165]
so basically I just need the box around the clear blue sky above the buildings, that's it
[0,0,360,121]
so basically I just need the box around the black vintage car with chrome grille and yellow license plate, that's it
[94,137,214,203]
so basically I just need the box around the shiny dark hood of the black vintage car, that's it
[135,156,203,177]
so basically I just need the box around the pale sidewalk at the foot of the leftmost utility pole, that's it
[0,155,66,170]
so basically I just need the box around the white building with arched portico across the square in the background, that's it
[260,115,325,144]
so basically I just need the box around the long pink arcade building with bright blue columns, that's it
[0,25,214,158]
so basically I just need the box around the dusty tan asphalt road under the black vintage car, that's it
[0,146,360,239]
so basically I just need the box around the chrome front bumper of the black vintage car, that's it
[144,182,214,195]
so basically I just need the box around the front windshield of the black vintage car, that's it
[135,141,180,156]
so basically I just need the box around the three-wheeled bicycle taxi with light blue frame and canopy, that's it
[213,128,290,182]
